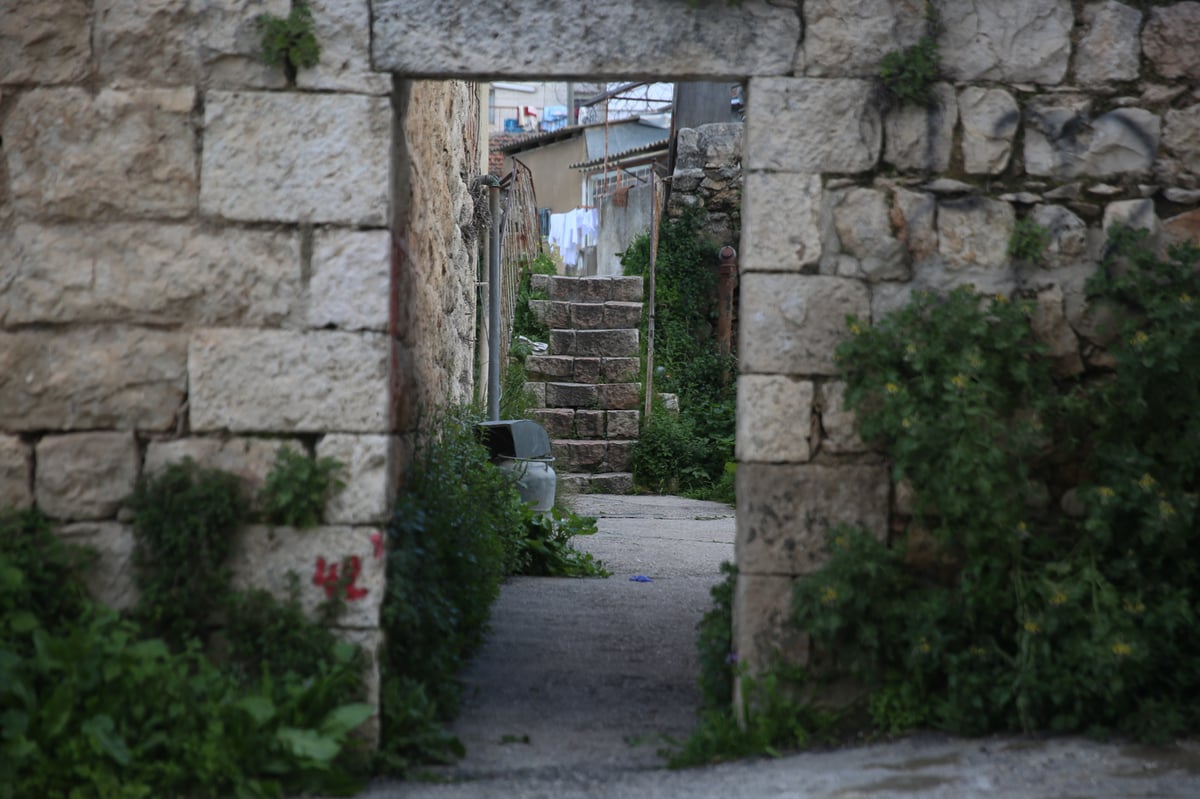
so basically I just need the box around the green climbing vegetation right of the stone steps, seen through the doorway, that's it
[622,211,737,501]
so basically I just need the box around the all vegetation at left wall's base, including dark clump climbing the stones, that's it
[0,448,374,799]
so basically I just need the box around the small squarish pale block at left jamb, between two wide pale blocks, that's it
[308,229,391,331]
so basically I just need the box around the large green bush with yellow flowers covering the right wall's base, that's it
[677,230,1200,763]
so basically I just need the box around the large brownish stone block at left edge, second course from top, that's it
[0,88,198,218]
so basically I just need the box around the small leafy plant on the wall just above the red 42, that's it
[259,446,346,528]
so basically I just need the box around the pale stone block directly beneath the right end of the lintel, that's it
[745,78,883,173]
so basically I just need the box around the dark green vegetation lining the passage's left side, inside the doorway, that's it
[379,409,606,773]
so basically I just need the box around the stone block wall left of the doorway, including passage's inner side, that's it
[0,0,478,705]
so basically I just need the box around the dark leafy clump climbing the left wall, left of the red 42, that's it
[126,458,247,649]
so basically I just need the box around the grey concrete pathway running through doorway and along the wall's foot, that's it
[360,495,1200,799]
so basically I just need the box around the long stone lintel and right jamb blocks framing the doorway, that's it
[371,0,859,668]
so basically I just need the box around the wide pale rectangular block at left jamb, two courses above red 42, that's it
[187,328,390,433]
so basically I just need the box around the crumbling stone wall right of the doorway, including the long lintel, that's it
[372,0,1200,686]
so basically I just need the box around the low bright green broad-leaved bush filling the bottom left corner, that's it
[0,513,373,799]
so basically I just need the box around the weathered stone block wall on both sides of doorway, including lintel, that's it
[0,0,1200,710]
